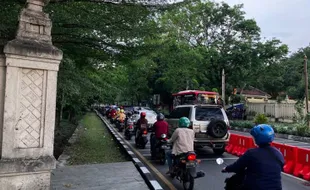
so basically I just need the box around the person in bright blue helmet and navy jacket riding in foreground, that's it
[222,124,285,190]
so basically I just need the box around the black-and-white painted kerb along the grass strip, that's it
[95,110,163,190]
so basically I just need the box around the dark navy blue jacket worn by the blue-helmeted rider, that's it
[226,145,285,190]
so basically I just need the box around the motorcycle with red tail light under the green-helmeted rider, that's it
[170,152,205,190]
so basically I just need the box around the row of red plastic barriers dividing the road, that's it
[225,134,310,181]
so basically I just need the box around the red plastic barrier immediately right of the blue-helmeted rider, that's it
[272,142,297,174]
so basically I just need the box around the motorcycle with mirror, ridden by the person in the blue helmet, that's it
[216,158,245,190]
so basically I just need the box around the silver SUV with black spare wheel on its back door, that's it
[166,105,230,155]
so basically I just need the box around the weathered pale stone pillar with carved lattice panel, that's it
[0,0,62,190]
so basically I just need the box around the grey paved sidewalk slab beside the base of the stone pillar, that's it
[51,162,149,190]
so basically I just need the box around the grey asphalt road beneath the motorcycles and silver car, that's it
[107,121,310,190]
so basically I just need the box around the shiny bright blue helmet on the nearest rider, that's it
[250,124,275,146]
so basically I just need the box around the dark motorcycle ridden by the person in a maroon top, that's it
[151,133,170,165]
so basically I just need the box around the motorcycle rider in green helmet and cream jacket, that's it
[166,117,195,174]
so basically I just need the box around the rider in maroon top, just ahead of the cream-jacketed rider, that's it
[151,113,169,157]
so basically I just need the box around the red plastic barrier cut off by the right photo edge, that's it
[293,148,310,180]
